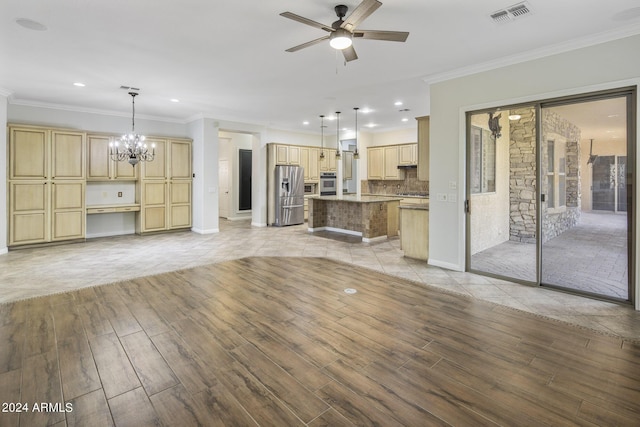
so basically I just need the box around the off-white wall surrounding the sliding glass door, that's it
[429,35,640,305]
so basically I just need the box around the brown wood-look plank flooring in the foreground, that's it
[0,257,640,427]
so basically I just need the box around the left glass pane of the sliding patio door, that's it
[468,107,537,282]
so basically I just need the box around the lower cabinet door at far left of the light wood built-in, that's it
[9,181,51,246]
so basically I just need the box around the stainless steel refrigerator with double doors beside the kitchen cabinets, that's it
[273,166,304,227]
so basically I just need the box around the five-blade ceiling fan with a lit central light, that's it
[280,0,409,61]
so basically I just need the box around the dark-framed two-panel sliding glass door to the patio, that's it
[467,90,635,302]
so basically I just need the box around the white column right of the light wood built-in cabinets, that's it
[189,118,220,234]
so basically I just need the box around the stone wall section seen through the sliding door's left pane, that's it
[509,108,536,243]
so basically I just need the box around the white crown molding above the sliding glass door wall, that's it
[422,24,640,84]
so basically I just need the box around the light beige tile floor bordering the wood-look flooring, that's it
[0,219,640,340]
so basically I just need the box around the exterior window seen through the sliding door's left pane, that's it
[470,126,496,194]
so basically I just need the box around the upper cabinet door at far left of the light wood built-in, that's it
[9,128,49,179]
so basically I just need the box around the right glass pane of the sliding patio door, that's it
[540,97,629,300]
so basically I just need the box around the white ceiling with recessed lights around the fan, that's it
[0,0,640,132]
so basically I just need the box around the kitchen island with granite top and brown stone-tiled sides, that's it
[308,195,401,242]
